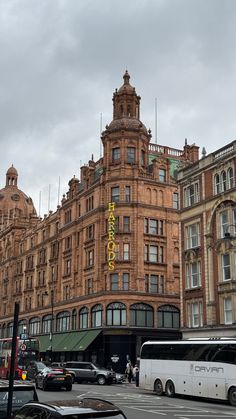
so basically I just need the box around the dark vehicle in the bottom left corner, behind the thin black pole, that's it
[0,380,38,419]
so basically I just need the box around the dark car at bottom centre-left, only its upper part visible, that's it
[14,398,126,419]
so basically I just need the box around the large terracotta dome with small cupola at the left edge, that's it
[0,165,37,229]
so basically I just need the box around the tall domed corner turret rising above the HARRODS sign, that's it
[101,70,151,169]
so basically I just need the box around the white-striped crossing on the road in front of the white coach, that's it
[79,391,236,419]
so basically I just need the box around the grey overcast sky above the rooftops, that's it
[0,0,236,216]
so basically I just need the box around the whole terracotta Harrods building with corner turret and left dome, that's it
[0,72,198,371]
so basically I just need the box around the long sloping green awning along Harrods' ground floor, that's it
[39,330,101,352]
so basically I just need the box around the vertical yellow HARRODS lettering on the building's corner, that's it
[107,202,116,271]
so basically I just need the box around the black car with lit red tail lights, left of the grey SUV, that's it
[35,367,72,391]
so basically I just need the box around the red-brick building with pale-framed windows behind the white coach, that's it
[178,141,236,338]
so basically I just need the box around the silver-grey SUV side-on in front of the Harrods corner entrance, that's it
[64,361,115,385]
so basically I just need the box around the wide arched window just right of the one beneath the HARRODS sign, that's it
[130,303,154,327]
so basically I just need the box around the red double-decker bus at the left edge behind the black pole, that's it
[0,337,39,379]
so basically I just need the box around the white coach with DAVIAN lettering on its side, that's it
[139,339,236,406]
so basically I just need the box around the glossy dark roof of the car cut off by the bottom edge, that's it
[19,397,121,415]
